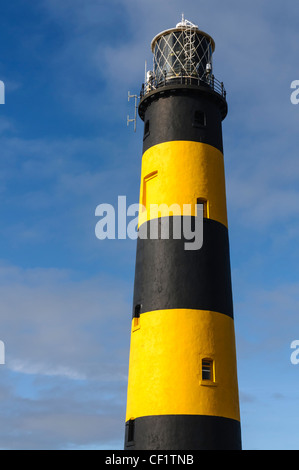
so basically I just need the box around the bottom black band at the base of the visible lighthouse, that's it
[125,415,242,450]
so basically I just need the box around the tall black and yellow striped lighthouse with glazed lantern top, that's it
[125,15,241,450]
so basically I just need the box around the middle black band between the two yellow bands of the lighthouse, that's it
[133,216,233,318]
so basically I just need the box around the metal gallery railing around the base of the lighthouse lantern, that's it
[140,74,226,99]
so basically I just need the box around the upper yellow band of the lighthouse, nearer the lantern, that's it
[139,141,227,227]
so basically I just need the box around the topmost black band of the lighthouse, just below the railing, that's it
[143,87,223,152]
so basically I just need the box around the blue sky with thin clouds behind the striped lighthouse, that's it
[0,0,299,449]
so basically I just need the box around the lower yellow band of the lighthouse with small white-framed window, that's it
[126,309,240,420]
